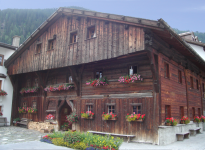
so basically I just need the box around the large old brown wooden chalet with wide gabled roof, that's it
[5,8,205,143]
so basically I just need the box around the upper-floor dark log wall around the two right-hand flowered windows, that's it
[82,54,153,96]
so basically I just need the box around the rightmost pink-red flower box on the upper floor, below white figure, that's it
[118,74,143,84]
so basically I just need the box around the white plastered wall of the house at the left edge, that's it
[0,47,15,125]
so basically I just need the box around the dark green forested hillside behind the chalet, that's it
[0,6,205,44]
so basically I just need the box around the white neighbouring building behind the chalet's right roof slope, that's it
[179,32,205,60]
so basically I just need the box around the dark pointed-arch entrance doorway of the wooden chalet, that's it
[59,101,72,129]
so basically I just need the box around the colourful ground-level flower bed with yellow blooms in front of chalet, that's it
[40,131,123,150]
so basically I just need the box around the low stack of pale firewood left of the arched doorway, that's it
[28,121,58,133]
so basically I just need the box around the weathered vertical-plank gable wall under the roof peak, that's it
[8,17,144,75]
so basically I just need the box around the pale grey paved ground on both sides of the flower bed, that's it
[0,127,205,150]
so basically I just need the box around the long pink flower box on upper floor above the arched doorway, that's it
[44,83,74,92]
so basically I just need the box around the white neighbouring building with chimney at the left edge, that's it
[0,36,20,125]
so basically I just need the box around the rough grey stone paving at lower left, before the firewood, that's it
[0,126,47,145]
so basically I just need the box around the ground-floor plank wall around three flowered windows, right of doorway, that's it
[75,98,158,143]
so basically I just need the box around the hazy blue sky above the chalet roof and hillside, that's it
[0,0,205,32]
